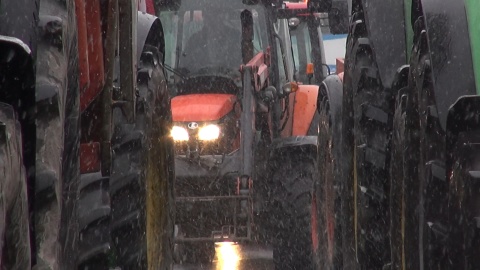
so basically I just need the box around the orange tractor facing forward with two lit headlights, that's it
[157,0,334,268]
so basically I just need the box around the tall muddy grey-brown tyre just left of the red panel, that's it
[34,0,80,270]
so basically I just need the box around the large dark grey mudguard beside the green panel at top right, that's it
[412,0,476,129]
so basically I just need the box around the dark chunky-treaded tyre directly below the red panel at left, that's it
[76,172,110,270]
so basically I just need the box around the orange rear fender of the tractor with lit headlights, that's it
[292,85,319,136]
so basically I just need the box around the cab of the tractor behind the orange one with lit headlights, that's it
[278,0,348,85]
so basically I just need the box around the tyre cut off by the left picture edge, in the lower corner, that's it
[0,103,31,269]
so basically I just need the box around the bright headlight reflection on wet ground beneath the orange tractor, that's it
[173,242,274,270]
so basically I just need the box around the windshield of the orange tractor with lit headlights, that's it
[159,0,267,94]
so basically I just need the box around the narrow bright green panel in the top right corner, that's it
[465,0,480,95]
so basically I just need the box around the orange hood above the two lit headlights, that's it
[171,94,236,122]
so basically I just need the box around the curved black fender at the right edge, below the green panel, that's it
[445,95,480,171]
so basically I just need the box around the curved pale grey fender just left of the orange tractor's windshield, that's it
[137,11,165,64]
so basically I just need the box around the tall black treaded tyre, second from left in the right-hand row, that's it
[343,7,393,269]
